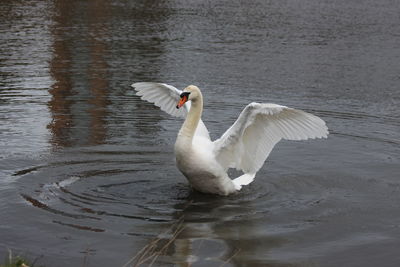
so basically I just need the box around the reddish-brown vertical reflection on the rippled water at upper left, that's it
[48,1,110,147]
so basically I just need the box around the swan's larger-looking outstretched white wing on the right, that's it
[214,103,328,173]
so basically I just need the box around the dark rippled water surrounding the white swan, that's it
[0,0,400,266]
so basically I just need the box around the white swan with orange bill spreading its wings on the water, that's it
[132,82,328,195]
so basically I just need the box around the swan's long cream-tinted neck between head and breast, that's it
[178,95,203,142]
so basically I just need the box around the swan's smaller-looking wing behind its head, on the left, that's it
[132,82,190,118]
